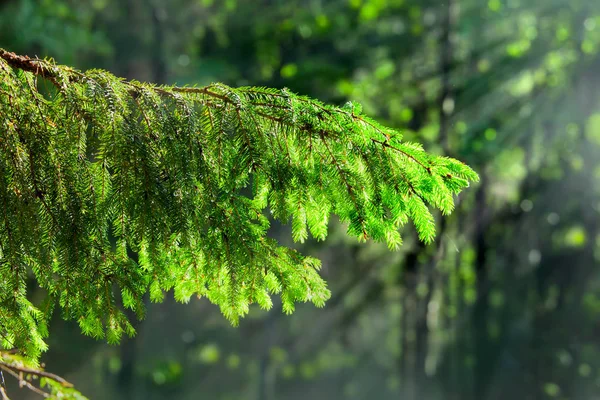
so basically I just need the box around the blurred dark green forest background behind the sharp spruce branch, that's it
[0,0,600,400]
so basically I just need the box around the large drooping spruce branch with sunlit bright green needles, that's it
[0,52,477,356]
